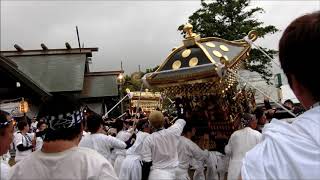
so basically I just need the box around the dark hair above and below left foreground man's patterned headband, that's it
[38,95,83,142]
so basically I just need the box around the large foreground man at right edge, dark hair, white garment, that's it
[241,11,320,179]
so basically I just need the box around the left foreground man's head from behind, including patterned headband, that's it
[38,95,83,141]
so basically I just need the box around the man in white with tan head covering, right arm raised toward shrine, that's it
[142,111,186,180]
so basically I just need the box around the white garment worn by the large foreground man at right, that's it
[241,106,320,179]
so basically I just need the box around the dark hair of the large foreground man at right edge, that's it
[279,11,320,101]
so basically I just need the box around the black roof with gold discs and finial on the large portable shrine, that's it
[144,24,257,88]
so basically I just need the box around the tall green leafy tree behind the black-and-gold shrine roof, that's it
[178,0,278,83]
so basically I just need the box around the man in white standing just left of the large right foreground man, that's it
[225,114,261,180]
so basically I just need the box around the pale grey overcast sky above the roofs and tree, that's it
[1,0,320,73]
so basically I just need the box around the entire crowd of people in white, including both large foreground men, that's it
[0,11,320,180]
